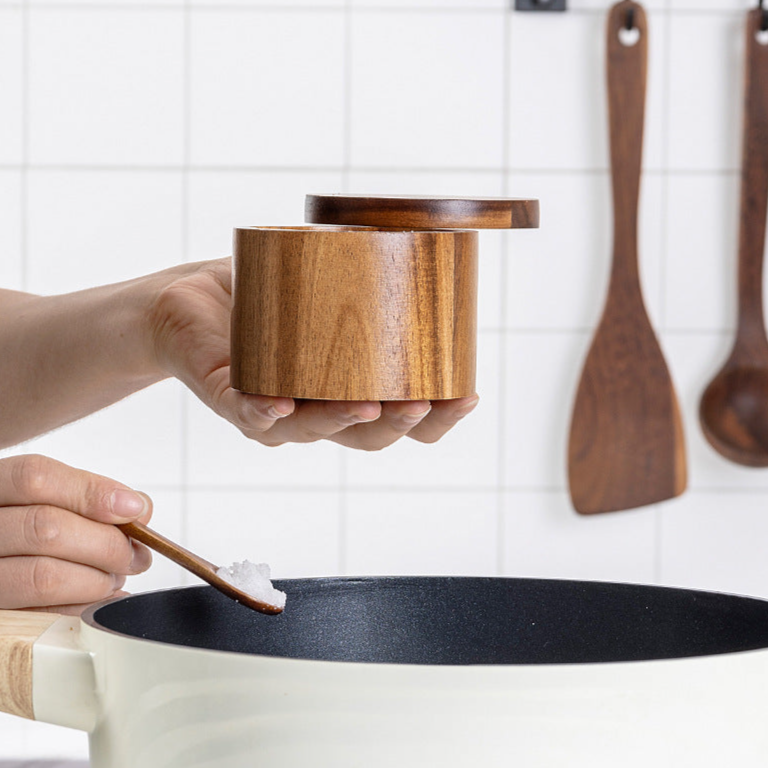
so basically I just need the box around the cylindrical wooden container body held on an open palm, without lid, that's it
[232,227,477,400]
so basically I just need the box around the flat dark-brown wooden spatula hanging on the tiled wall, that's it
[568,0,686,514]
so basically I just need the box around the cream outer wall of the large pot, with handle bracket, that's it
[27,618,768,768]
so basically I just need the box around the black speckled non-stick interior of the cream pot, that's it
[90,577,768,664]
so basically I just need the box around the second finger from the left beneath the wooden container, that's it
[244,400,382,445]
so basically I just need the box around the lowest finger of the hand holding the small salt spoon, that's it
[0,557,125,609]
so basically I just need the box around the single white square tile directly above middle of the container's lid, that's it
[349,10,505,169]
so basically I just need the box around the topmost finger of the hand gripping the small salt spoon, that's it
[0,454,152,523]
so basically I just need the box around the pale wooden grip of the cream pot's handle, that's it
[0,611,60,720]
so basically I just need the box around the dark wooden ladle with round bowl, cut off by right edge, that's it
[699,8,768,467]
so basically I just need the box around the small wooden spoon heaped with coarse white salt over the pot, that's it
[117,523,285,614]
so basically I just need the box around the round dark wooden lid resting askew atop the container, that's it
[304,195,539,229]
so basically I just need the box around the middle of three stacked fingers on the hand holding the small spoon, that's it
[0,504,152,575]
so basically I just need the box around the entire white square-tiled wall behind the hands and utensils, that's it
[0,0,768,758]
